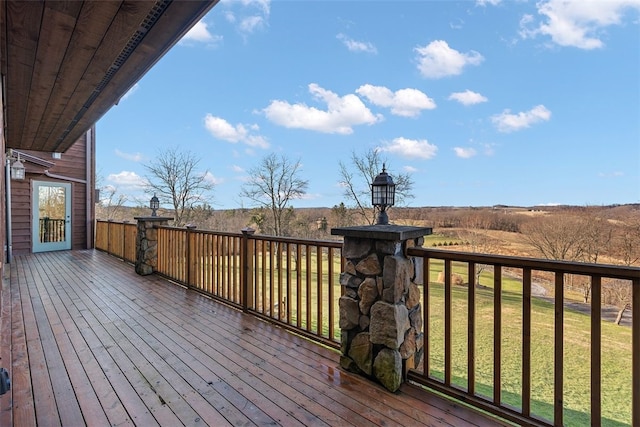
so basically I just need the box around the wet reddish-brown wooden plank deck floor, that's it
[0,251,510,427]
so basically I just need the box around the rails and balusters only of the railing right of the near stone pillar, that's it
[407,247,640,426]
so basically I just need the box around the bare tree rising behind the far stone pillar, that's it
[145,148,213,227]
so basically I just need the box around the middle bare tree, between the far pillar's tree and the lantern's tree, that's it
[240,153,309,236]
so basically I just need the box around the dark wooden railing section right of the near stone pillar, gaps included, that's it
[408,248,640,426]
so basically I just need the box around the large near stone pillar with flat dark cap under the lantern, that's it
[331,225,431,392]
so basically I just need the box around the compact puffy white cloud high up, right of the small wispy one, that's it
[414,40,484,79]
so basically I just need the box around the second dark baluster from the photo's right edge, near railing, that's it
[591,276,602,427]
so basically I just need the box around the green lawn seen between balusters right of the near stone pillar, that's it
[428,284,632,426]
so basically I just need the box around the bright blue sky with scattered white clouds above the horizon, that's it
[96,0,640,209]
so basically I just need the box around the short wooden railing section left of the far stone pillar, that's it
[95,221,137,262]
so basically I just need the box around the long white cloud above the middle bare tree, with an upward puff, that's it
[262,83,382,135]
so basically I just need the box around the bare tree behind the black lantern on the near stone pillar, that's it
[339,149,413,224]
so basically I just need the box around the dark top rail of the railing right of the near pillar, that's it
[407,247,640,280]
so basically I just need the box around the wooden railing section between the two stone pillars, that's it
[152,226,342,348]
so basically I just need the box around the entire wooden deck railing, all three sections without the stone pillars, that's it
[96,221,640,426]
